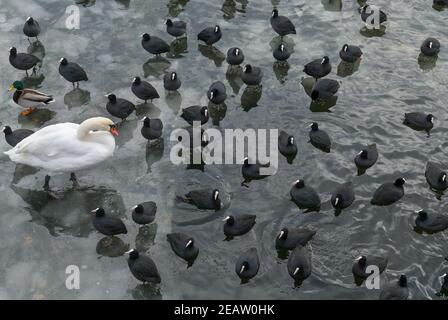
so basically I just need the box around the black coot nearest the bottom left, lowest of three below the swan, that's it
[126,249,161,284]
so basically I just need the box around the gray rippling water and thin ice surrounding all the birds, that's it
[0,0,448,299]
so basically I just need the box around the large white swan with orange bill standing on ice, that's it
[5,117,118,190]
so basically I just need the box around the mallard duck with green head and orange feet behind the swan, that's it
[9,81,54,116]
